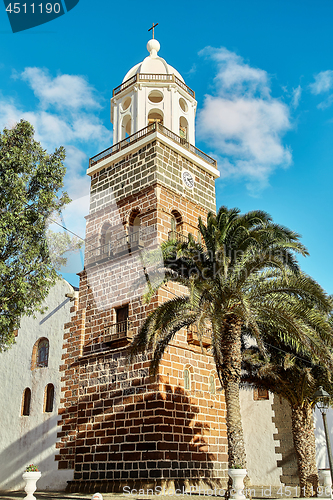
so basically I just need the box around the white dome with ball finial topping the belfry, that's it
[123,39,184,82]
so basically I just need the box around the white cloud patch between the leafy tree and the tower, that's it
[0,68,111,230]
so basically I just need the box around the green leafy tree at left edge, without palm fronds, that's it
[0,120,70,350]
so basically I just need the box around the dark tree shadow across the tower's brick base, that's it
[65,380,225,493]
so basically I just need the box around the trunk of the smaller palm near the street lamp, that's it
[291,405,318,497]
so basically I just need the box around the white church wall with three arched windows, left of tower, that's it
[0,280,73,491]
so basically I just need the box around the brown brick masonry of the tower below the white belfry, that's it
[56,140,227,491]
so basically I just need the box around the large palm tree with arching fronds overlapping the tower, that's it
[131,207,329,476]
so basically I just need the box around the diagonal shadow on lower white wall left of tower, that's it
[0,415,72,492]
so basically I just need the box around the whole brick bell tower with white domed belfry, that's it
[57,33,227,492]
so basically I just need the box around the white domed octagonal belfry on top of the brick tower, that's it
[111,39,197,145]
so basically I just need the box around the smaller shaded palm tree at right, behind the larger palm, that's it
[242,336,333,497]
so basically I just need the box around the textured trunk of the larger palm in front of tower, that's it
[221,316,246,469]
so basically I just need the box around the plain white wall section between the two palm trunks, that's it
[240,390,282,486]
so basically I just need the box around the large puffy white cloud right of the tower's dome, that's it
[198,47,290,190]
